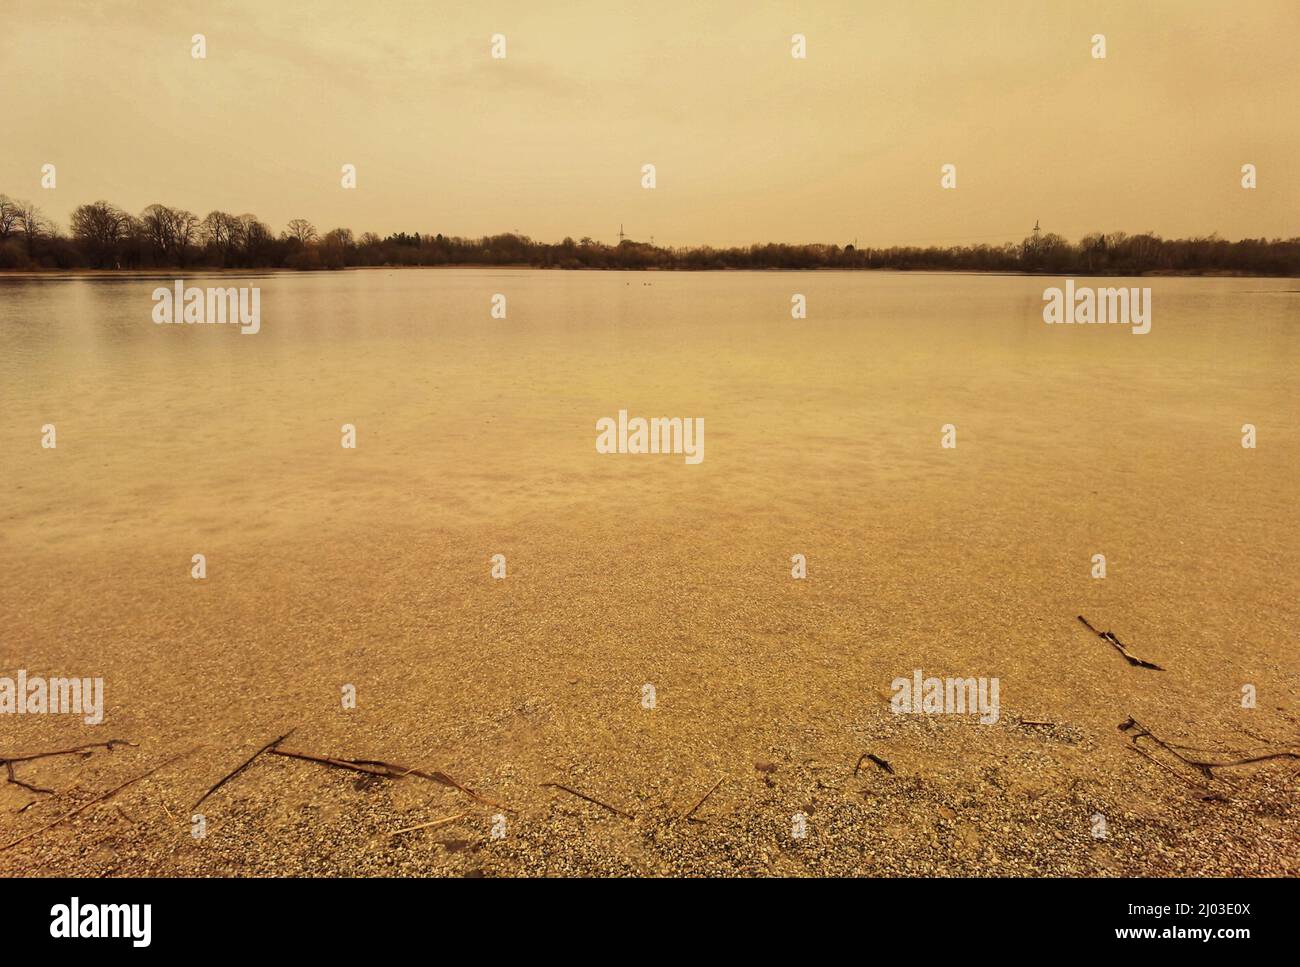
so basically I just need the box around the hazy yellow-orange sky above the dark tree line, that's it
[0,0,1300,244]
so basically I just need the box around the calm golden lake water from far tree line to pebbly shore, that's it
[0,269,1300,821]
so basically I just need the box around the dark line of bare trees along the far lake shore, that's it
[0,195,1300,276]
